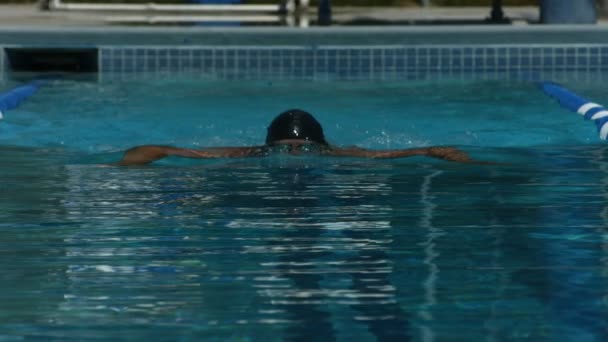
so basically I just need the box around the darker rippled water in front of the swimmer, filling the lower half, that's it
[0,146,608,341]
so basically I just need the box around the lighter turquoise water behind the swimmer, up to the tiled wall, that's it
[0,79,606,152]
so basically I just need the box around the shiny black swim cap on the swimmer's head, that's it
[266,109,327,145]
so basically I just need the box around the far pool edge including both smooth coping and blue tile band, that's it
[0,26,608,80]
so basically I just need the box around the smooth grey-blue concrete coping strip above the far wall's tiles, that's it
[0,25,608,47]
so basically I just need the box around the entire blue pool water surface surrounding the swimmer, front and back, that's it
[0,75,608,341]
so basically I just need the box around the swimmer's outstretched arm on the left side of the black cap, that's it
[117,145,263,166]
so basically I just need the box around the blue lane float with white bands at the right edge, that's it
[540,82,608,140]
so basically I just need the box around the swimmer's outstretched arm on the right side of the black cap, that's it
[326,147,475,163]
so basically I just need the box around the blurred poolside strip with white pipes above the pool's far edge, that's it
[0,0,608,27]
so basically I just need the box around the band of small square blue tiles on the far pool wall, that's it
[0,44,592,81]
